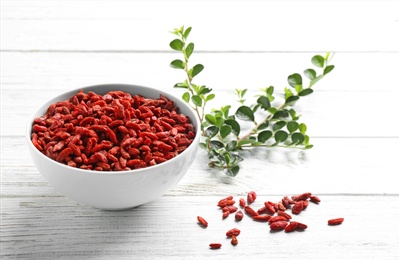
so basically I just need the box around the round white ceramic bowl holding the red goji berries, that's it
[26,84,200,210]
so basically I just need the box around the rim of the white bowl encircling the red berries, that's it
[25,83,201,176]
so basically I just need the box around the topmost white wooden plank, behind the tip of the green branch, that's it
[1,1,399,52]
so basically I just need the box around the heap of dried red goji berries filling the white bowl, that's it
[31,91,195,171]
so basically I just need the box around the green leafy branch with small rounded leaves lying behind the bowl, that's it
[170,27,334,176]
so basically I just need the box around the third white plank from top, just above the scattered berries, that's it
[1,137,399,197]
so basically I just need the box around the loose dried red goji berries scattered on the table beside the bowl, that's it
[197,191,344,249]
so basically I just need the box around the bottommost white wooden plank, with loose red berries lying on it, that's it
[0,196,399,259]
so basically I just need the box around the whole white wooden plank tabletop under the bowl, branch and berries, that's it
[0,1,399,259]
